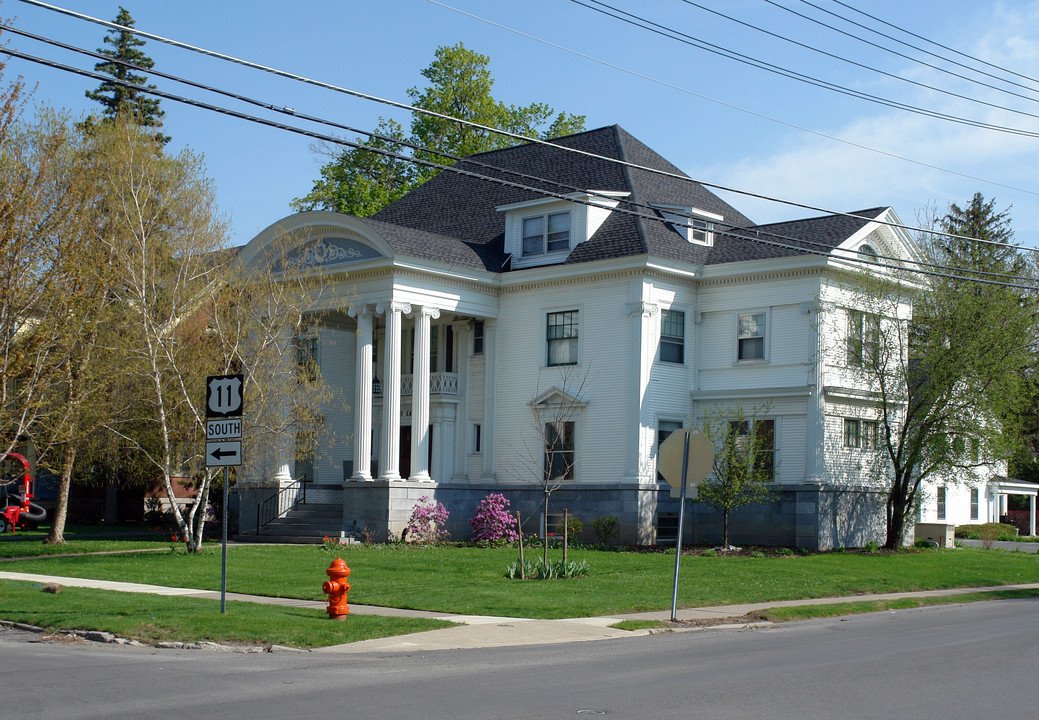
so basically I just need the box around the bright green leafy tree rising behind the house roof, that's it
[292,43,585,217]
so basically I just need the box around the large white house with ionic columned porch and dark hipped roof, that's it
[233,126,1005,549]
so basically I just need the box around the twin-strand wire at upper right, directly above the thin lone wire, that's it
[570,0,1039,137]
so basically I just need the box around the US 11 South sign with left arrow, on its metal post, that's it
[206,375,245,615]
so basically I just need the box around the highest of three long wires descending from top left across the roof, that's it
[12,0,1039,252]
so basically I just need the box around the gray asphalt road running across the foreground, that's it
[0,599,1039,720]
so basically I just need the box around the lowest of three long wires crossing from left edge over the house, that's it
[0,40,1039,290]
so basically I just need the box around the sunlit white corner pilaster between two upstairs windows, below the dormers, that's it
[624,297,659,483]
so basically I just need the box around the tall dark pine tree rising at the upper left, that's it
[86,5,169,144]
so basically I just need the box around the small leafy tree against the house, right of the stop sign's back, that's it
[696,407,776,548]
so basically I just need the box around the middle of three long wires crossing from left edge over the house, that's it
[10,23,1032,282]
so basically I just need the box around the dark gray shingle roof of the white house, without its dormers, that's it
[363,126,877,272]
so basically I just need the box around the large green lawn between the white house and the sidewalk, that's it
[0,543,1039,618]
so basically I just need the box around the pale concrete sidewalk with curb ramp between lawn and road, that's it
[0,571,1039,652]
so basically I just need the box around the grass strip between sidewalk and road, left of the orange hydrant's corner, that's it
[0,580,452,647]
